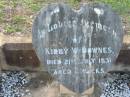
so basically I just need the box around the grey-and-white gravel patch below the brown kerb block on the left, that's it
[0,71,30,97]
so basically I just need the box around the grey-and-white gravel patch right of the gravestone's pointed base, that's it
[100,73,130,97]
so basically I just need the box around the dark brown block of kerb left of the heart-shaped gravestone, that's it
[2,43,42,71]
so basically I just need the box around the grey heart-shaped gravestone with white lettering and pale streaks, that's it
[32,4,123,93]
